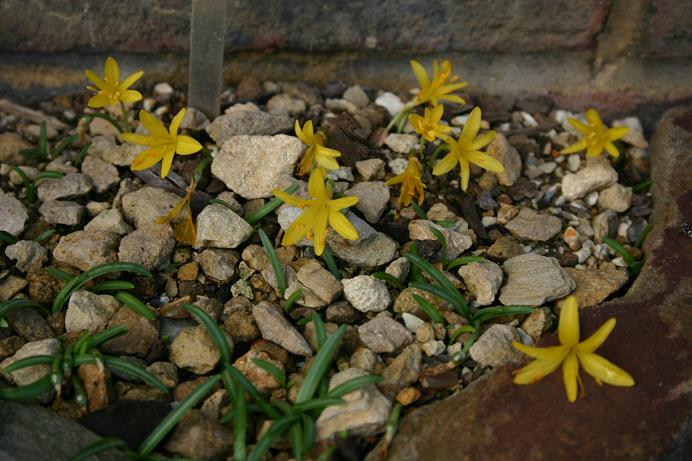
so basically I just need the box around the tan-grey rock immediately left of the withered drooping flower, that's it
[122,186,180,228]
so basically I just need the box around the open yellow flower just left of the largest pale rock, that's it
[120,109,202,178]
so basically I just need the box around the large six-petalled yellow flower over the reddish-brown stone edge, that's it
[512,296,634,402]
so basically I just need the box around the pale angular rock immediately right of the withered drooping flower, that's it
[195,205,253,248]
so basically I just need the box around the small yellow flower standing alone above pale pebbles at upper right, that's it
[560,109,629,158]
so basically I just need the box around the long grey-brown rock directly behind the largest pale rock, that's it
[206,110,293,146]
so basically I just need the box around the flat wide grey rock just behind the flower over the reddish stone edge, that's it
[500,253,576,306]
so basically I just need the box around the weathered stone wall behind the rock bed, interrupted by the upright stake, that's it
[0,0,692,124]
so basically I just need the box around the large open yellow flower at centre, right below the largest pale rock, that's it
[272,169,358,256]
